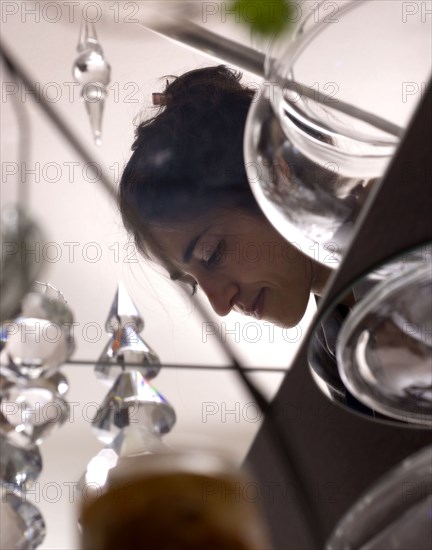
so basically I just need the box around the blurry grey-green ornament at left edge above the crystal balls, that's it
[0,206,43,326]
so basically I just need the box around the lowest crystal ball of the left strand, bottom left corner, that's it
[0,484,45,550]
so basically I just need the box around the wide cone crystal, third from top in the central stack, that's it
[92,371,176,443]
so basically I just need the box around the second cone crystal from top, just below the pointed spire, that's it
[95,326,160,384]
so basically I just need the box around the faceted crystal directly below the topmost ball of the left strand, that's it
[0,378,69,447]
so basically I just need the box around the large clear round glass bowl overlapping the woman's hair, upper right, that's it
[245,0,431,267]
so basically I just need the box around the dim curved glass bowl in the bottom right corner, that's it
[325,447,432,550]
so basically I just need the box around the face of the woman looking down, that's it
[152,210,313,327]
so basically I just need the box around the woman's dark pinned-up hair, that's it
[118,65,260,256]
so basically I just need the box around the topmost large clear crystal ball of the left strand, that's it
[2,292,74,378]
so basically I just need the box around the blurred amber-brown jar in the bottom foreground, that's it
[80,451,271,550]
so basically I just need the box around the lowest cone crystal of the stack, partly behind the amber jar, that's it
[77,425,168,499]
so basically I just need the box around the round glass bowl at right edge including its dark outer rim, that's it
[308,244,432,426]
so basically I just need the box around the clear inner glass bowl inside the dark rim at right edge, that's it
[336,260,432,426]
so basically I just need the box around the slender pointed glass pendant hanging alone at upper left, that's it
[73,21,111,146]
